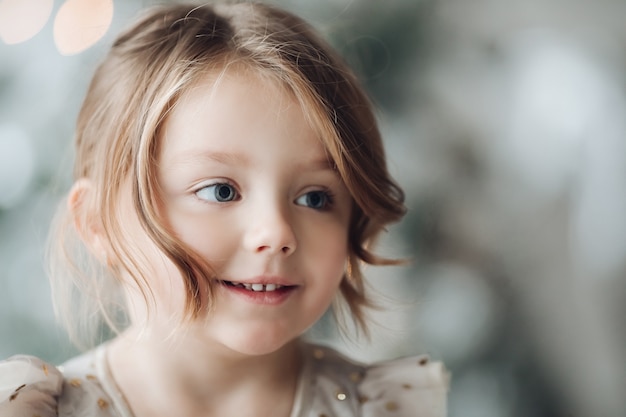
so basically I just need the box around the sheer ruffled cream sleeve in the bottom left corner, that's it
[0,355,63,417]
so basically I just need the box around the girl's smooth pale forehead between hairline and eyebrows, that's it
[158,65,331,166]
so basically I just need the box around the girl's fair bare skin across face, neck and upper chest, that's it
[71,68,352,417]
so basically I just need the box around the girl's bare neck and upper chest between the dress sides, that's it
[109,329,301,417]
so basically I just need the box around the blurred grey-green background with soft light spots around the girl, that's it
[0,0,626,417]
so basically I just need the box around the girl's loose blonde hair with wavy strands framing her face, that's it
[49,3,405,348]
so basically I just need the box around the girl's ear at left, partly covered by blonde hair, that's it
[67,178,109,264]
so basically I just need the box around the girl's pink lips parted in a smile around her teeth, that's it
[220,276,300,306]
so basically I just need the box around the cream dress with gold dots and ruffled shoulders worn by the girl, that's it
[0,345,448,417]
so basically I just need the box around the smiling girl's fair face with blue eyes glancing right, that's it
[139,70,352,354]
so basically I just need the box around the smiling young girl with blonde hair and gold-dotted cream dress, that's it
[0,3,447,417]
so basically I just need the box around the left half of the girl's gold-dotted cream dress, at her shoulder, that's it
[0,352,115,417]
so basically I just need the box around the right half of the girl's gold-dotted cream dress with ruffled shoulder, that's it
[301,346,448,417]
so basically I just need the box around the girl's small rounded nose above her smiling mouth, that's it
[244,201,297,256]
